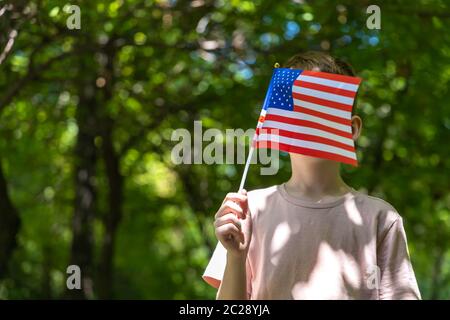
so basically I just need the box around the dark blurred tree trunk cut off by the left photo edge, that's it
[0,160,20,279]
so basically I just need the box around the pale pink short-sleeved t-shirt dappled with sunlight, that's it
[203,184,421,299]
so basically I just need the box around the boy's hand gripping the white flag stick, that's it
[214,190,252,256]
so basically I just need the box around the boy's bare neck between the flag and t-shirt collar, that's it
[285,161,351,201]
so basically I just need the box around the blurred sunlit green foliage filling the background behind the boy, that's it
[0,0,450,299]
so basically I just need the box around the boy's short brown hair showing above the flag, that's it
[283,51,356,115]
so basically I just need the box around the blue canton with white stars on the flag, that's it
[264,68,302,110]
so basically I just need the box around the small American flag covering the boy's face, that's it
[254,68,361,166]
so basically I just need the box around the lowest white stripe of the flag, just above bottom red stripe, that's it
[258,133,356,160]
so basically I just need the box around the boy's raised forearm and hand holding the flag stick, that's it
[214,190,252,300]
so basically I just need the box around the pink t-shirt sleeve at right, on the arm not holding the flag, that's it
[377,216,421,300]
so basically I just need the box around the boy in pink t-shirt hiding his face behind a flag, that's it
[204,52,421,299]
